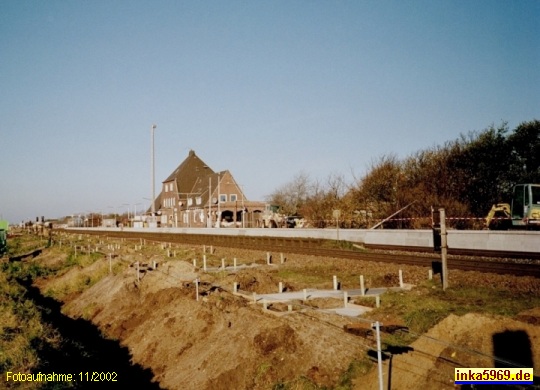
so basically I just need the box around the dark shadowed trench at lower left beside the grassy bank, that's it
[17,279,161,389]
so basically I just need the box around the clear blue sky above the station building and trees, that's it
[0,0,540,223]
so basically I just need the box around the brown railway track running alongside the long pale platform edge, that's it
[67,230,540,278]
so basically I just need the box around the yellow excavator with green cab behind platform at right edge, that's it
[486,184,540,230]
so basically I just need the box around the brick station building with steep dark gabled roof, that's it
[155,150,265,227]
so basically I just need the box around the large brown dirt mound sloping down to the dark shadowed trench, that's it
[53,261,362,389]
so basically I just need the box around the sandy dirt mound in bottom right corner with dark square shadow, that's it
[355,308,540,390]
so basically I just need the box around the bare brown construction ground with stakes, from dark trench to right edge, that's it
[31,238,540,389]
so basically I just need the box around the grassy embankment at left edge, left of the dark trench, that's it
[0,232,114,389]
